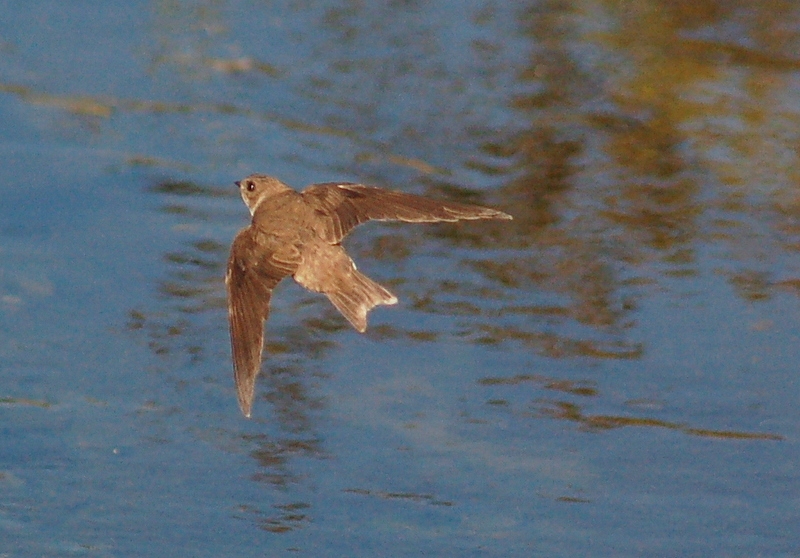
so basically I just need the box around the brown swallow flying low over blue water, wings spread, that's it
[225,174,511,417]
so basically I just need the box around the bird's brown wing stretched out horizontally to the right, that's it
[302,182,511,244]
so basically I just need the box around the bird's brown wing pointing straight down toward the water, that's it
[225,227,297,417]
